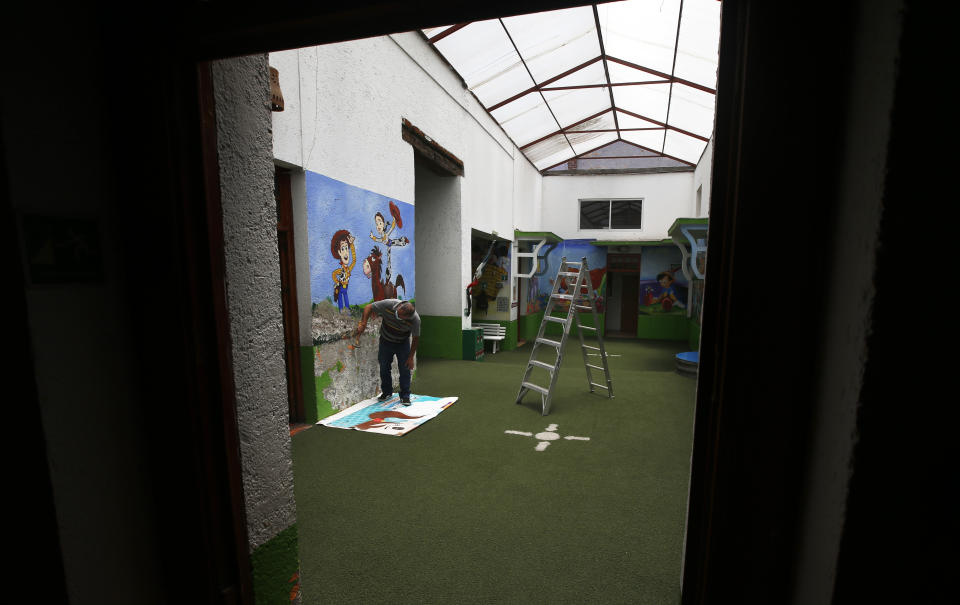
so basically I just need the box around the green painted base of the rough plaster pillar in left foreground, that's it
[250,523,300,605]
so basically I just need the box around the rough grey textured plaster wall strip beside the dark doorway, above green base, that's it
[213,55,296,551]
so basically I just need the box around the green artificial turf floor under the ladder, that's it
[293,339,696,605]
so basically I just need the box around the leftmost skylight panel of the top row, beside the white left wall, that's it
[434,19,532,89]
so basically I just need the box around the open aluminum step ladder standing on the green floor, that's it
[517,257,613,416]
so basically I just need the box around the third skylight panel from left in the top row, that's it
[597,0,680,73]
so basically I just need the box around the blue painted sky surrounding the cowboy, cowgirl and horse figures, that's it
[305,171,416,306]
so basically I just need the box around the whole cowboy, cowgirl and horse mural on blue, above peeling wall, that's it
[306,171,416,308]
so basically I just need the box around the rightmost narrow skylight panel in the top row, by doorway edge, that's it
[674,0,720,88]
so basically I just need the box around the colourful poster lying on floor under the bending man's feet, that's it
[317,394,457,437]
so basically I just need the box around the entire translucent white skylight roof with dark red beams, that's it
[421,0,720,173]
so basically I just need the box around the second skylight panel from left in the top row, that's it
[503,6,600,82]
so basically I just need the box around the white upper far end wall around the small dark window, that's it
[541,171,695,240]
